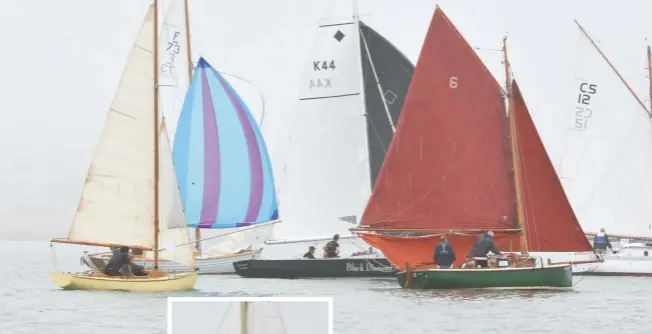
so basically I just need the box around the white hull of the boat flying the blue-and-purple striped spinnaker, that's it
[82,249,262,275]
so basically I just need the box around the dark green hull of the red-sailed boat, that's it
[397,265,573,289]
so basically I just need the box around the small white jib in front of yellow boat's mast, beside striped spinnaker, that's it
[159,122,195,270]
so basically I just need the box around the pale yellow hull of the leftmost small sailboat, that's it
[50,272,197,292]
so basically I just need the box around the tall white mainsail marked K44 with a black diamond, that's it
[274,1,371,238]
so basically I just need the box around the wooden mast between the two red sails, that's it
[503,36,528,253]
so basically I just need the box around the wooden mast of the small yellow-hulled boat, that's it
[154,0,159,270]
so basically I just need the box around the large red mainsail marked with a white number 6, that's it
[362,8,516,231]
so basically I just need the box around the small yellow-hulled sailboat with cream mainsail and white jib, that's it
[50,0,197,291]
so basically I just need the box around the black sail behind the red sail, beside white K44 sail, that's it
[360,22,414,188]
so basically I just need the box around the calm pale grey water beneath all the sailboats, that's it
[0,242,652,334]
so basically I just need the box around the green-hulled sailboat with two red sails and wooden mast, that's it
[354,7,591,289]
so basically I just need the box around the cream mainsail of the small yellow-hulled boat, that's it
[68,8,154,247]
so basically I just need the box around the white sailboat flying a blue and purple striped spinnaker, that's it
[82,0,278,274]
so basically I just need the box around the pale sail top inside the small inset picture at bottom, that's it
[217,301,287,334]
